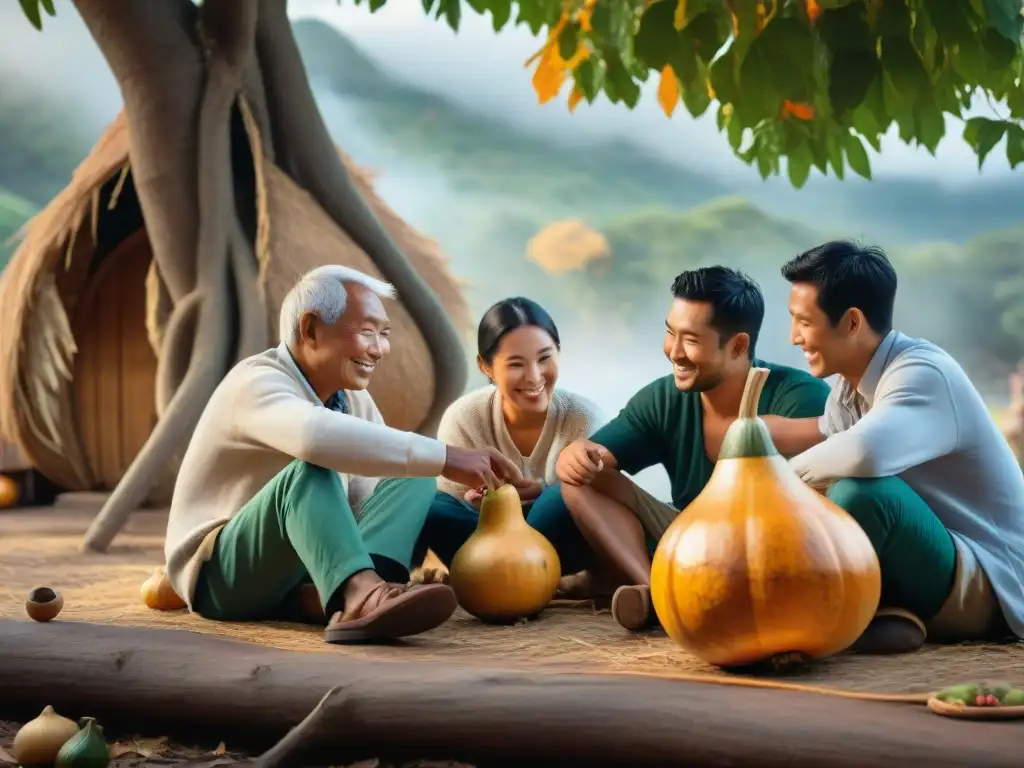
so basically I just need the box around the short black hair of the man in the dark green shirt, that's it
[672,266,765,359]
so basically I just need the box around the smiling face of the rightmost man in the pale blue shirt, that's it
[790,283,857,379]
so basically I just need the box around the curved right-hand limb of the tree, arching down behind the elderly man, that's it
[256,0,467,434]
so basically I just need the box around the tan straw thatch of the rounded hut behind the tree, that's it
[0,113,470,487]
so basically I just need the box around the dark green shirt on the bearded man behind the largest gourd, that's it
[591,360,829,509]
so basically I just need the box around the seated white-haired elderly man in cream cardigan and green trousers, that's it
[164,265,521,643]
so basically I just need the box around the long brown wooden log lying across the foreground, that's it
[0,620,1024,768]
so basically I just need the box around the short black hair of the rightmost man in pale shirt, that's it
[782,240,896,336]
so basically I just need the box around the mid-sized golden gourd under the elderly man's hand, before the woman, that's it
[450,485,561,624]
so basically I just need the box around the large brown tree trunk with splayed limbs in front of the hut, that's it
[75,0,466,552]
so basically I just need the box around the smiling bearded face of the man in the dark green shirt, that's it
[664,299,750,392]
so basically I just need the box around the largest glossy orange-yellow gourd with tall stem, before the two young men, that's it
[650,369,882,667]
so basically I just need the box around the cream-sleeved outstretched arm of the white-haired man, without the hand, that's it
[231,368,447,477]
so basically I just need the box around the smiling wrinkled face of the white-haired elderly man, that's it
[296,283,391,399]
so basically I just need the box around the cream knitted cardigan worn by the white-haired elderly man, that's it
[164,344,446,609]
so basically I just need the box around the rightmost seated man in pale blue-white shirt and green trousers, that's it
[781,243,1024,652]
